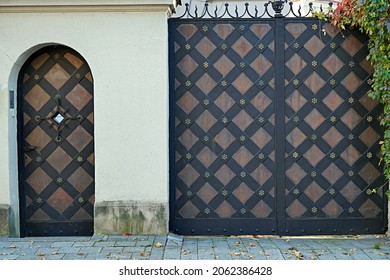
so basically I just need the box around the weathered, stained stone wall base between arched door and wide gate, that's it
[95,201,168,235]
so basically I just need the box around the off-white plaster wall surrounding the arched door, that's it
[0,3,169,234]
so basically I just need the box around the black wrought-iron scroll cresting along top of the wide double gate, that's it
[172,0,333,19]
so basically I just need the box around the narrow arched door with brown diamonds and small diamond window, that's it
[18,45,95,236]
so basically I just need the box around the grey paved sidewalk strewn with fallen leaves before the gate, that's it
[0,234,390,260]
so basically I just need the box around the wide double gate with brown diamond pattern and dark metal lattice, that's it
[169,2,387,235]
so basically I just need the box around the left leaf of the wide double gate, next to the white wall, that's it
[171,21,276,234]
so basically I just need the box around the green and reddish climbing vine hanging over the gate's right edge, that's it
[313,0,390,198]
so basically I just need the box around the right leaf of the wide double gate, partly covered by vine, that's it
[285,20,384,234]
